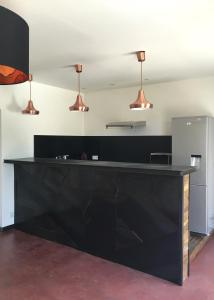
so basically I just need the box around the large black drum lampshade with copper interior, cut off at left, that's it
[0,6,29,84]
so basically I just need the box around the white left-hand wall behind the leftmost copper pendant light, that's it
[0,82,84,227]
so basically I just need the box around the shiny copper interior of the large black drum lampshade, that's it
[0,65,28,84]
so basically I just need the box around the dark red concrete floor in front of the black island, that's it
[0,230,214,300]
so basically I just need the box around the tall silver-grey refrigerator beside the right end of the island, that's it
[172,116,214,235]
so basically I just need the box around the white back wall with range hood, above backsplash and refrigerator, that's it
[85,77,214,135]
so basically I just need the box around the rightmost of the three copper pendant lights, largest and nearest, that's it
[129,51,153,110]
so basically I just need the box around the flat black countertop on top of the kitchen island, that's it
[4,157,197,176]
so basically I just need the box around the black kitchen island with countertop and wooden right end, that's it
[5,158,195,284]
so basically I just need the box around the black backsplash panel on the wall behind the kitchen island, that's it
[34,135,172,163]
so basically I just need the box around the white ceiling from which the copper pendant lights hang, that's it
[0,0,214,92]
